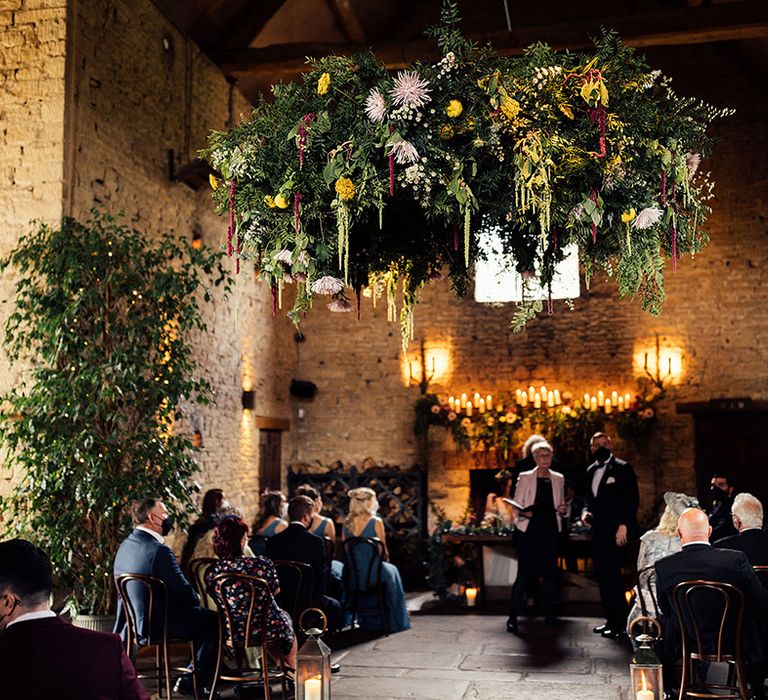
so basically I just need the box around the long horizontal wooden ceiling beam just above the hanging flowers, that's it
[209,0,768,77]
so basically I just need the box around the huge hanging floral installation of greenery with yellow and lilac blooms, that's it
[204,0,732,344]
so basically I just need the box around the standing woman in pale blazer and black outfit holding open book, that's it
[507,442,569,634]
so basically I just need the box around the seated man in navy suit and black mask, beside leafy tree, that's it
[114,498,219,695]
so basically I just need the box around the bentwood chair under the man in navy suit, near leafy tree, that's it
[115,574,199,700]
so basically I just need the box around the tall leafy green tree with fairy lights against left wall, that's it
[0,211,230,614]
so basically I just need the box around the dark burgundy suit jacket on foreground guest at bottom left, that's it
[0,617,149,700]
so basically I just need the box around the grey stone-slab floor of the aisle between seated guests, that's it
[332,615,631,700]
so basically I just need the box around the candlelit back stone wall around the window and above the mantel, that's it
[294,43,768,528]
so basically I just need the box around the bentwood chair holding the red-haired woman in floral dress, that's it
[209,574,288,700]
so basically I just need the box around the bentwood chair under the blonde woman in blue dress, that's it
[344,537,389,634]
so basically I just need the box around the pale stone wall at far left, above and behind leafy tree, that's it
[0,0,66,493]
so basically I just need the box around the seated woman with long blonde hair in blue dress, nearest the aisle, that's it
[342,487,411,632]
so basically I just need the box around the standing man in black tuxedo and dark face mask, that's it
[582,433,640,639]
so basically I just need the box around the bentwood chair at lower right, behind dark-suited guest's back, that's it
[672,580,749,700]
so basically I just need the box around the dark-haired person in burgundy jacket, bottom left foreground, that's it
[0,539,149,700]
